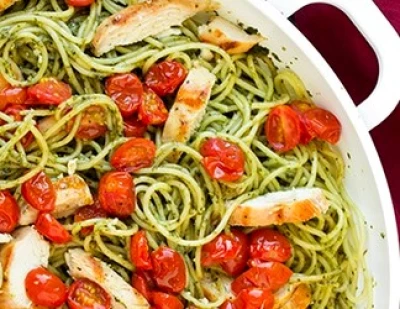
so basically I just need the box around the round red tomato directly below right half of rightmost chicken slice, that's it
[250,229,292,263]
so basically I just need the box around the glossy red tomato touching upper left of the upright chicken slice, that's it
[144,61,187,97]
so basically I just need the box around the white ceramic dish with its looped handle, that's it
[219,0,400,309]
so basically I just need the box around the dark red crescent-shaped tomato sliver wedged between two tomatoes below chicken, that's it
[221,229,249,277]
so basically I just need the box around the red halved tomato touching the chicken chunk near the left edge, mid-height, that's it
[21,171,56,212]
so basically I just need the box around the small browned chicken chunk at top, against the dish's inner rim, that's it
[199,16,264,54]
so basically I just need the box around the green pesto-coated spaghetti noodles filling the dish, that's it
[0,0,373,308]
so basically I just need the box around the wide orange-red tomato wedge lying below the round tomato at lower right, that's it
[231,262,293,295]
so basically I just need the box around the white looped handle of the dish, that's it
[267,0,400,130]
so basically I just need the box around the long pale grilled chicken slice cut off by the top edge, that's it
[92,0,217,56]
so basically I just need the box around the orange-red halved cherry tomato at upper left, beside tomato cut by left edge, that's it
[27,78,72,105]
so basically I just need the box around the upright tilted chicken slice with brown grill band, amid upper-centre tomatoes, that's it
[162,67,216,143]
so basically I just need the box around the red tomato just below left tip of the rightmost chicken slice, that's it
[201,230,248,267]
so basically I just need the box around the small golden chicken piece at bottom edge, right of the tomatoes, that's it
[274,283,311,309]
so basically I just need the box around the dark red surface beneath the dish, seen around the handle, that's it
[293,0,400,233]
